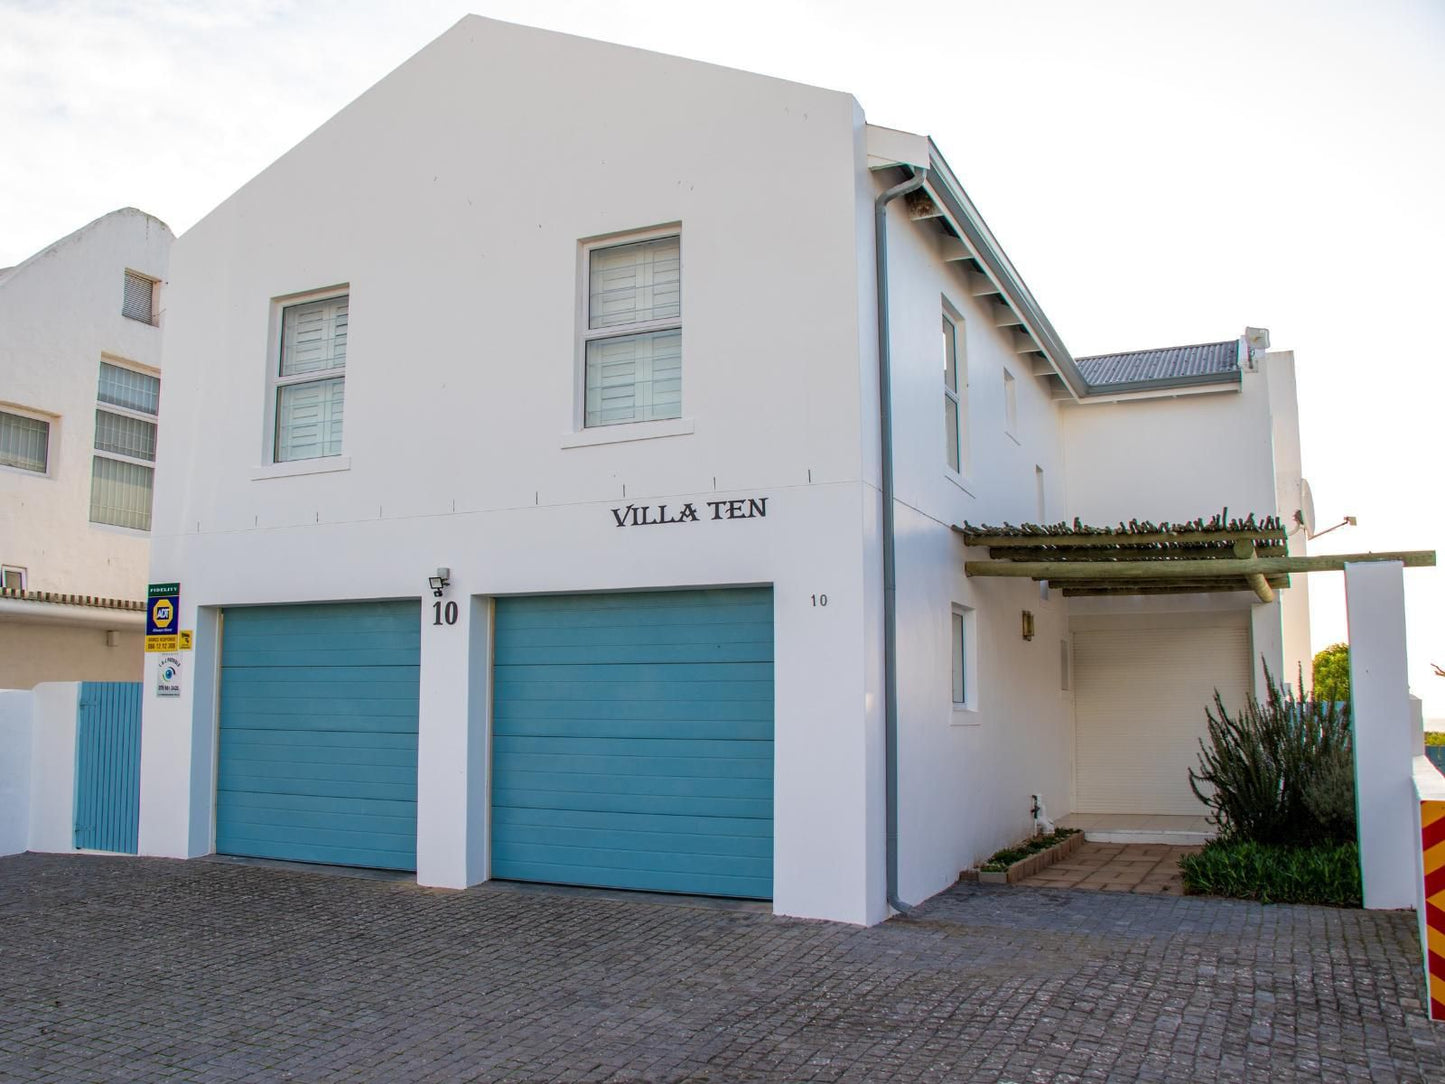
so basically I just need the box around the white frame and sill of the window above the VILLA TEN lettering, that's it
[562,223,694,448]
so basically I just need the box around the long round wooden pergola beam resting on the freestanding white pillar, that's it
[964,549,1435,584]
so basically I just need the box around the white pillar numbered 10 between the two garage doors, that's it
[416,587,491,889]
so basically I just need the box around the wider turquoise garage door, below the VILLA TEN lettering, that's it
[491,588,773,899]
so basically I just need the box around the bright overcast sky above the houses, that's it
[8,0,1445,717]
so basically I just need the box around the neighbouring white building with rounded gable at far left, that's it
[0,207,173,688]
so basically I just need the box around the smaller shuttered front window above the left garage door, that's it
[272,293,350,463]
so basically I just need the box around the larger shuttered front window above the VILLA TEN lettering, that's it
[582,233,682,426]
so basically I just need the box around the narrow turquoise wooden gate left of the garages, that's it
[75,681,140,854]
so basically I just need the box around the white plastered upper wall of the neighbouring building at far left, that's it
[0,208,172,604]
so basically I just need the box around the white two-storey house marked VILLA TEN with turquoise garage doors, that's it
[140,17,1308,922]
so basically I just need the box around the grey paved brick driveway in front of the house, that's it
[0,854,1445,1081]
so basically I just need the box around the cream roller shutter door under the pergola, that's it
[1074,619,1251,815]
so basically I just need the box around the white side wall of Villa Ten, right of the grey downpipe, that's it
[861,182,1074,903]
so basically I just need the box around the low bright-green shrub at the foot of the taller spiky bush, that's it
[1179,840,1363,908]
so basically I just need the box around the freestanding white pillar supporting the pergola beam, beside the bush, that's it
[1345,561,1418,911]
